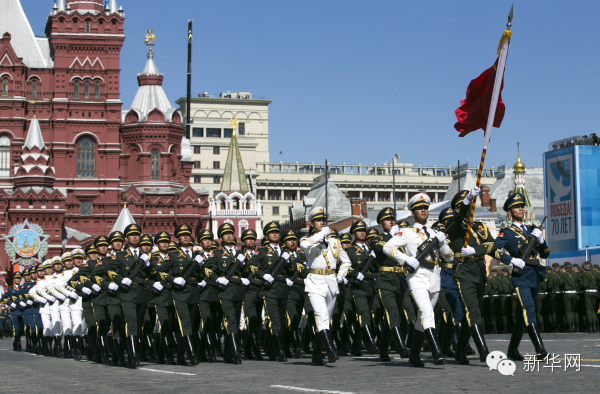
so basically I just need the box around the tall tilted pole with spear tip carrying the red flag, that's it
[459,6,513,248]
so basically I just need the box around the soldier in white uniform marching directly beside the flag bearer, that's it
[383,193,454,367]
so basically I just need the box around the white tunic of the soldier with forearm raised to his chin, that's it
[300,232,352,297]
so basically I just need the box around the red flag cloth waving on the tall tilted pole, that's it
[454,59,505,137]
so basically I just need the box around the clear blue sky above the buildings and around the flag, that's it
[22,0,600,171]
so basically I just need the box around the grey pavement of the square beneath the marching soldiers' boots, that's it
[0,334,600,394]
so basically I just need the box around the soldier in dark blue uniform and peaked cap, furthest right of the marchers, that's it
[496,193,550,360]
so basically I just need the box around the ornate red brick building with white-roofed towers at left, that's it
[0,0,208,280]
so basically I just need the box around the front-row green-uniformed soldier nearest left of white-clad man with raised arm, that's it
[249,222,293,362]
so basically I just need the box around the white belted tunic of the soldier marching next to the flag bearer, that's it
[383,223,454,292]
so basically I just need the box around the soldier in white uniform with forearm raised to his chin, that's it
[300,207,352,365]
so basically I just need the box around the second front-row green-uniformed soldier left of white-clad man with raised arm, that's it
[205,223,247,364]
